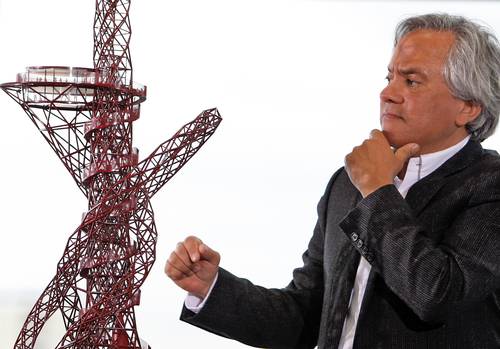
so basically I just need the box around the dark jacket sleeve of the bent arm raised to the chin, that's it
[340,177,500,323]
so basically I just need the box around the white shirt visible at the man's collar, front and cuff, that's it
[184,136,470,349]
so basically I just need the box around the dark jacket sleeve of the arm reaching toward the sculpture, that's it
[181,170,340,349]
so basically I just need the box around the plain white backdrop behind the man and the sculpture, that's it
[0,0,500,349]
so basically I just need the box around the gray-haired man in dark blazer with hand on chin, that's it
[165,14,500,349]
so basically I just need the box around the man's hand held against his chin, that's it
[344,130,420,197]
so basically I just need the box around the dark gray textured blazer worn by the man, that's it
[181,141,500,349]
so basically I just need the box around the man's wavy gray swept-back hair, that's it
[394,13,500,142]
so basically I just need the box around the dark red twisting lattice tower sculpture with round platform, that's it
[0,0,221,349]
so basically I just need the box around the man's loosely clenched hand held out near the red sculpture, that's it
[165,236,220,299]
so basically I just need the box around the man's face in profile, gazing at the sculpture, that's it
[380,30,474,154]
